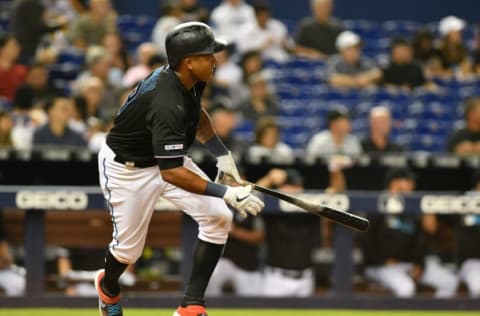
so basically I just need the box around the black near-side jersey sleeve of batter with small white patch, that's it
[151,89,187,159]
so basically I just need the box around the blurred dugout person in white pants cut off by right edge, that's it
[455,169,480,298]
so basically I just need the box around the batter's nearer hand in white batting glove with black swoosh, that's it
[223,185,265,218]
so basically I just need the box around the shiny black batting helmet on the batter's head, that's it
[165,22,227,69]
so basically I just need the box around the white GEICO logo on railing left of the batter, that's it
[16,191,88,210]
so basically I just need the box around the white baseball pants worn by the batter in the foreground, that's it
[98,144,232,264]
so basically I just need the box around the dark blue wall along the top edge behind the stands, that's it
[115,0,480,23]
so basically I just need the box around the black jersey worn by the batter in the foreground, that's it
[107,66,205,165]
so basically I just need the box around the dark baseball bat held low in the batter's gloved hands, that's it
[243,181,369,232]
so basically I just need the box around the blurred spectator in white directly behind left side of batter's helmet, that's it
[152,0,182,56]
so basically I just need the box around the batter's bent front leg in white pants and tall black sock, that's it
[162,158,233,315]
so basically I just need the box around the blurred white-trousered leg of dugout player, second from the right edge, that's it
[420,260,458,298]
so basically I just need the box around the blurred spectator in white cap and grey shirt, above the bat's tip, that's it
[328,31,382,88]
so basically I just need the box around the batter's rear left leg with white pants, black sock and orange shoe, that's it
[95,146,164,315]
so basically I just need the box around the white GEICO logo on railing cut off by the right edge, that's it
[420,195,480,213]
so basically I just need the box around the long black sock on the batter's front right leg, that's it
[181,239,224,307]
